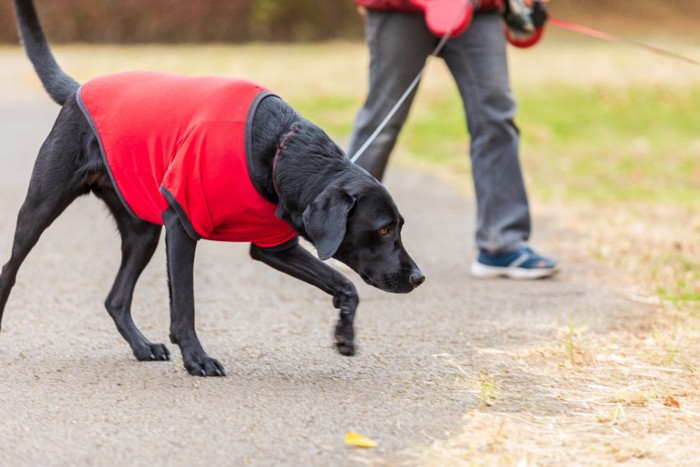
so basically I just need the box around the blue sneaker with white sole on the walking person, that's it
[471,246,559,279]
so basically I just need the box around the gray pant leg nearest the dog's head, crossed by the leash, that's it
[348,10,438,180]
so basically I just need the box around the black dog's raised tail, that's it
[15,0,80,105]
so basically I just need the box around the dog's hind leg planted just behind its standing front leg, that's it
[93,189,170,361]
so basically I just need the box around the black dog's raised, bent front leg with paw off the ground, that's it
[250,244,360,356]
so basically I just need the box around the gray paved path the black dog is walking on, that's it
[0,89,648,466]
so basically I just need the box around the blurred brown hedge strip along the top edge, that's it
[0,0,700,43]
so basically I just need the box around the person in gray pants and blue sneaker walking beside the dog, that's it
[348,0,558,279]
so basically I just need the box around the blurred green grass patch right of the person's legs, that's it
[520,87,700,207]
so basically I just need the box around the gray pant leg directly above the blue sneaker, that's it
[441,13,531,253]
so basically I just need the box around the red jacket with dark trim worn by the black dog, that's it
[77,72,296,248]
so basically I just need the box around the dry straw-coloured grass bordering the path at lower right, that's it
[410,194,700,466]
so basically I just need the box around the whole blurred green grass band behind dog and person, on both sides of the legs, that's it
[293,85,700,208]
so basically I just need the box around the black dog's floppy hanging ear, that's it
[303,187,355,260]
